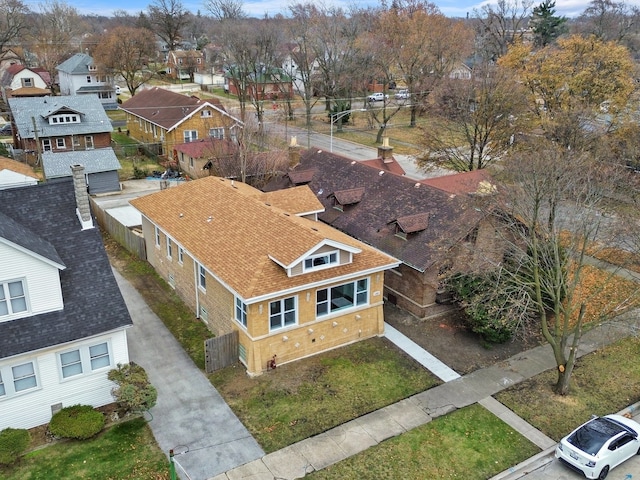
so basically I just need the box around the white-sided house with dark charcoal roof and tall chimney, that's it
[0,170,132,430]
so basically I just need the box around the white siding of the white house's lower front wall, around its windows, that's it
[0,330,129,430]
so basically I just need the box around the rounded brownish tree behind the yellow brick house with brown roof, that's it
[94,27,156,95]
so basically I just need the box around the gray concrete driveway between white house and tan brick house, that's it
[114,271,264,480]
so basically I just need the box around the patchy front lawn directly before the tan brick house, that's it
[209,338,440,452]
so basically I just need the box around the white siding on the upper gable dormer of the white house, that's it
[0,243,63,321]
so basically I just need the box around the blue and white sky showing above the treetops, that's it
[25,0,640,17]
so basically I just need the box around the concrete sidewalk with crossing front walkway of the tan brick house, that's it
[212,311,638,480]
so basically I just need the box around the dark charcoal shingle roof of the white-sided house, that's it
[0,180,131,358]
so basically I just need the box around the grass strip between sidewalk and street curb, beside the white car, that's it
[305,404,540,480]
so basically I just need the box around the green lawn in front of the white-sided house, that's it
[0,418,169,480]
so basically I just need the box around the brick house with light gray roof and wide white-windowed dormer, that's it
[9,96,113,164]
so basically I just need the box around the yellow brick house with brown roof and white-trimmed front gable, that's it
[120,87,244,157]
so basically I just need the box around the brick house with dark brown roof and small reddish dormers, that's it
[265,150,506,318]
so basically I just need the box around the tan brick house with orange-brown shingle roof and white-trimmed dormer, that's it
[131,177,399,375]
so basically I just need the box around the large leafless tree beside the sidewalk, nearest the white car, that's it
[497,139,637,395]
